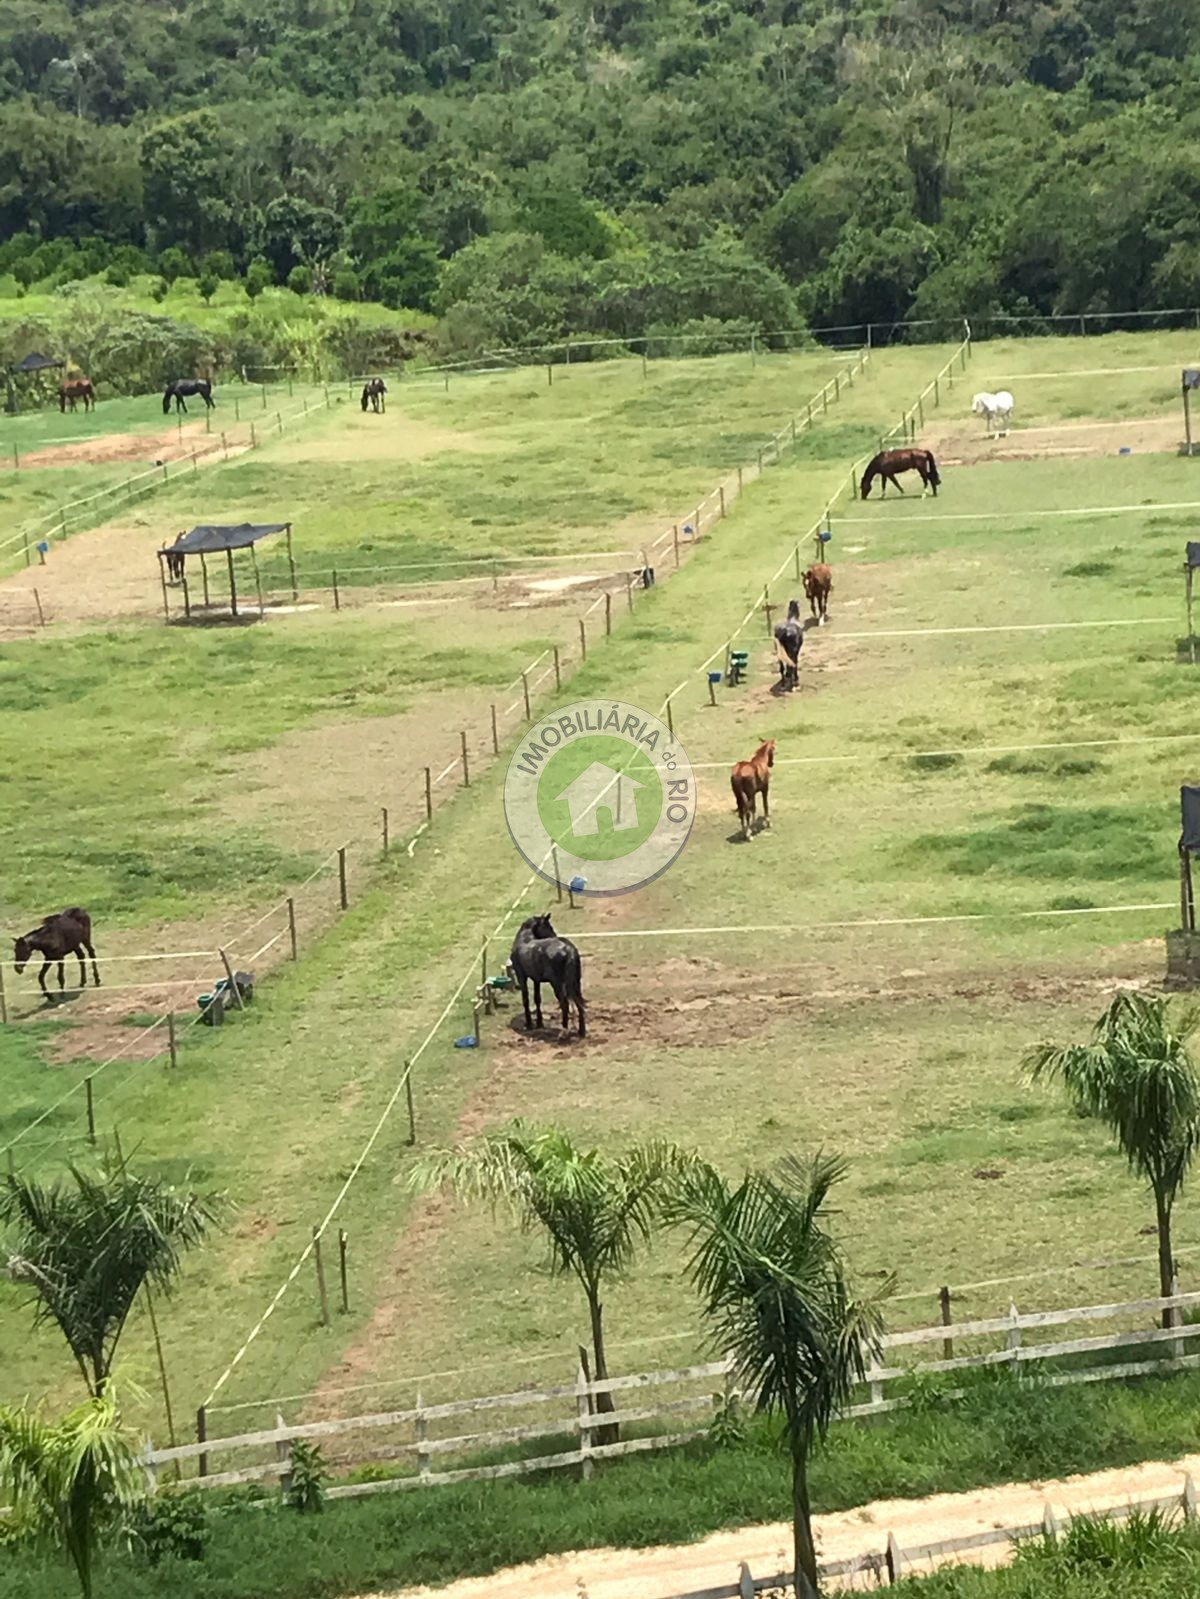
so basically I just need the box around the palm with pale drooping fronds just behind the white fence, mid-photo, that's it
[410,1121,691,1444]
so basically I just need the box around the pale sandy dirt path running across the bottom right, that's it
[376,1455,1200,1599]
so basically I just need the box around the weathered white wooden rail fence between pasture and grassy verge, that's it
[144,1294,1200,1498]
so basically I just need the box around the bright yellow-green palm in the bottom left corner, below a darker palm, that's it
[0,1390,146,1599]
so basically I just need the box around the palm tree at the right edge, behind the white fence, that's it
[1024,991,1200,1327]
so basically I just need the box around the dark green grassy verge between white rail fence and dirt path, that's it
[0,1372,1200,1599]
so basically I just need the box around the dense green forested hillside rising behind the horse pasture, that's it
[0,0,1200,345]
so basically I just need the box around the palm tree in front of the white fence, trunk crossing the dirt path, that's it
[667,1154,890,1596]
